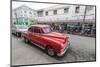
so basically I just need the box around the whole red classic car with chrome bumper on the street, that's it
[22,25,70,56]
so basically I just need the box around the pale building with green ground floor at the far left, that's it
[12,5,37,24]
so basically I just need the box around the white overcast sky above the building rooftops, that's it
[12,1,58,10]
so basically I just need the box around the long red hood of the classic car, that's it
[42,32,67,43]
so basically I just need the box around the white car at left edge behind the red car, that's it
[12,25,28,37]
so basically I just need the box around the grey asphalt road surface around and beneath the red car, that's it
[11,35,96,65]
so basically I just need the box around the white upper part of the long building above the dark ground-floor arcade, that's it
[36,5,95,23]
